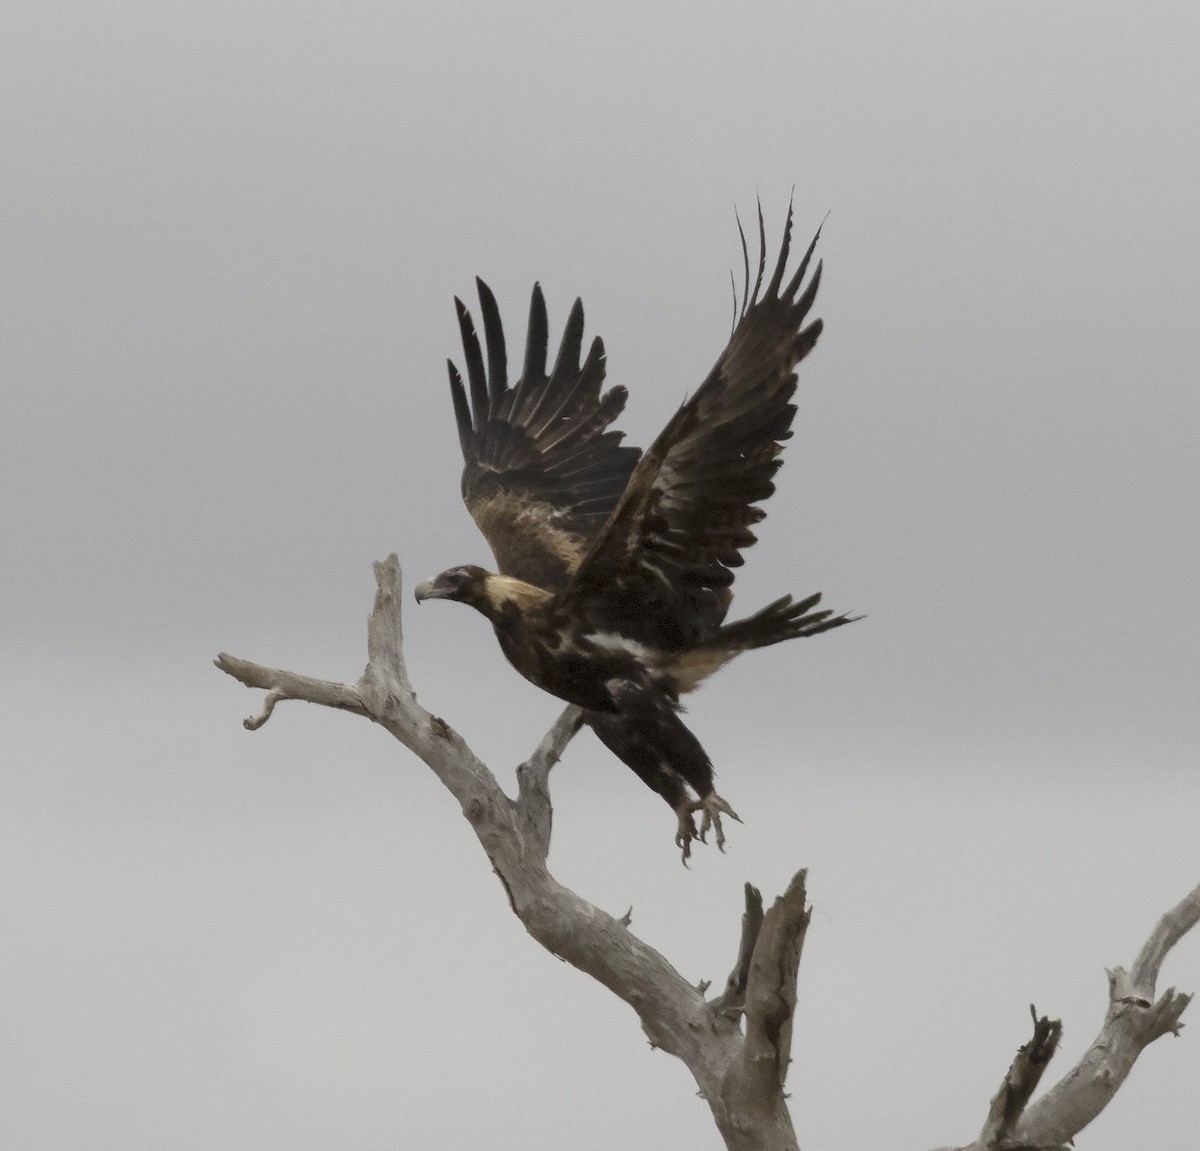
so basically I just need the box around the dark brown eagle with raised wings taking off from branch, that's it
[415,204,858,864]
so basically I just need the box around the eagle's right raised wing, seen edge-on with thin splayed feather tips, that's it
[562,206,821,648]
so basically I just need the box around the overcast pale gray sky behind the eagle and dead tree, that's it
[0,0,1200,1151]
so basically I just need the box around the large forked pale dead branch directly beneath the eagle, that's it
[216,556,808,1151]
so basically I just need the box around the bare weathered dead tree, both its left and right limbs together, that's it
[216,556,1200,1151]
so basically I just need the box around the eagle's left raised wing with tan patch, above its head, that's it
[448,280,641,592]
